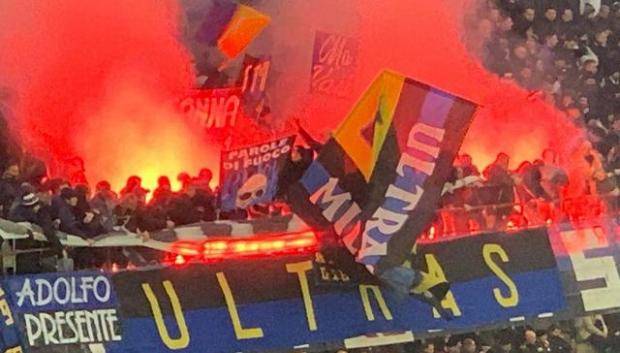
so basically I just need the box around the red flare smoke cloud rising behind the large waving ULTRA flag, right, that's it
[256,0,582,191]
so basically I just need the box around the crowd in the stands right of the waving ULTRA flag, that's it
[430,0,620,237]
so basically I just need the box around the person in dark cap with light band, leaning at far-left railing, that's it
[9,192,64,256]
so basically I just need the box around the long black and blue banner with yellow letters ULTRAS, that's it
[112,229,564,353]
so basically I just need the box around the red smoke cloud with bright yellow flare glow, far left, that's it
[0,0,217,189]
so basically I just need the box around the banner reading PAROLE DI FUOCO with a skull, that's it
[220,136,295,211]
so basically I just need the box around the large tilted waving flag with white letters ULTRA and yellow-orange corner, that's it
[289,72,476,272]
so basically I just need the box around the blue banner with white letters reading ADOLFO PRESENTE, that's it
[4,272,123,352]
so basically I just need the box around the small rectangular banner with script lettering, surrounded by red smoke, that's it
[310,31,359,97]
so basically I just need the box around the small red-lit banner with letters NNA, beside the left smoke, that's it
[178,87,241,129]
